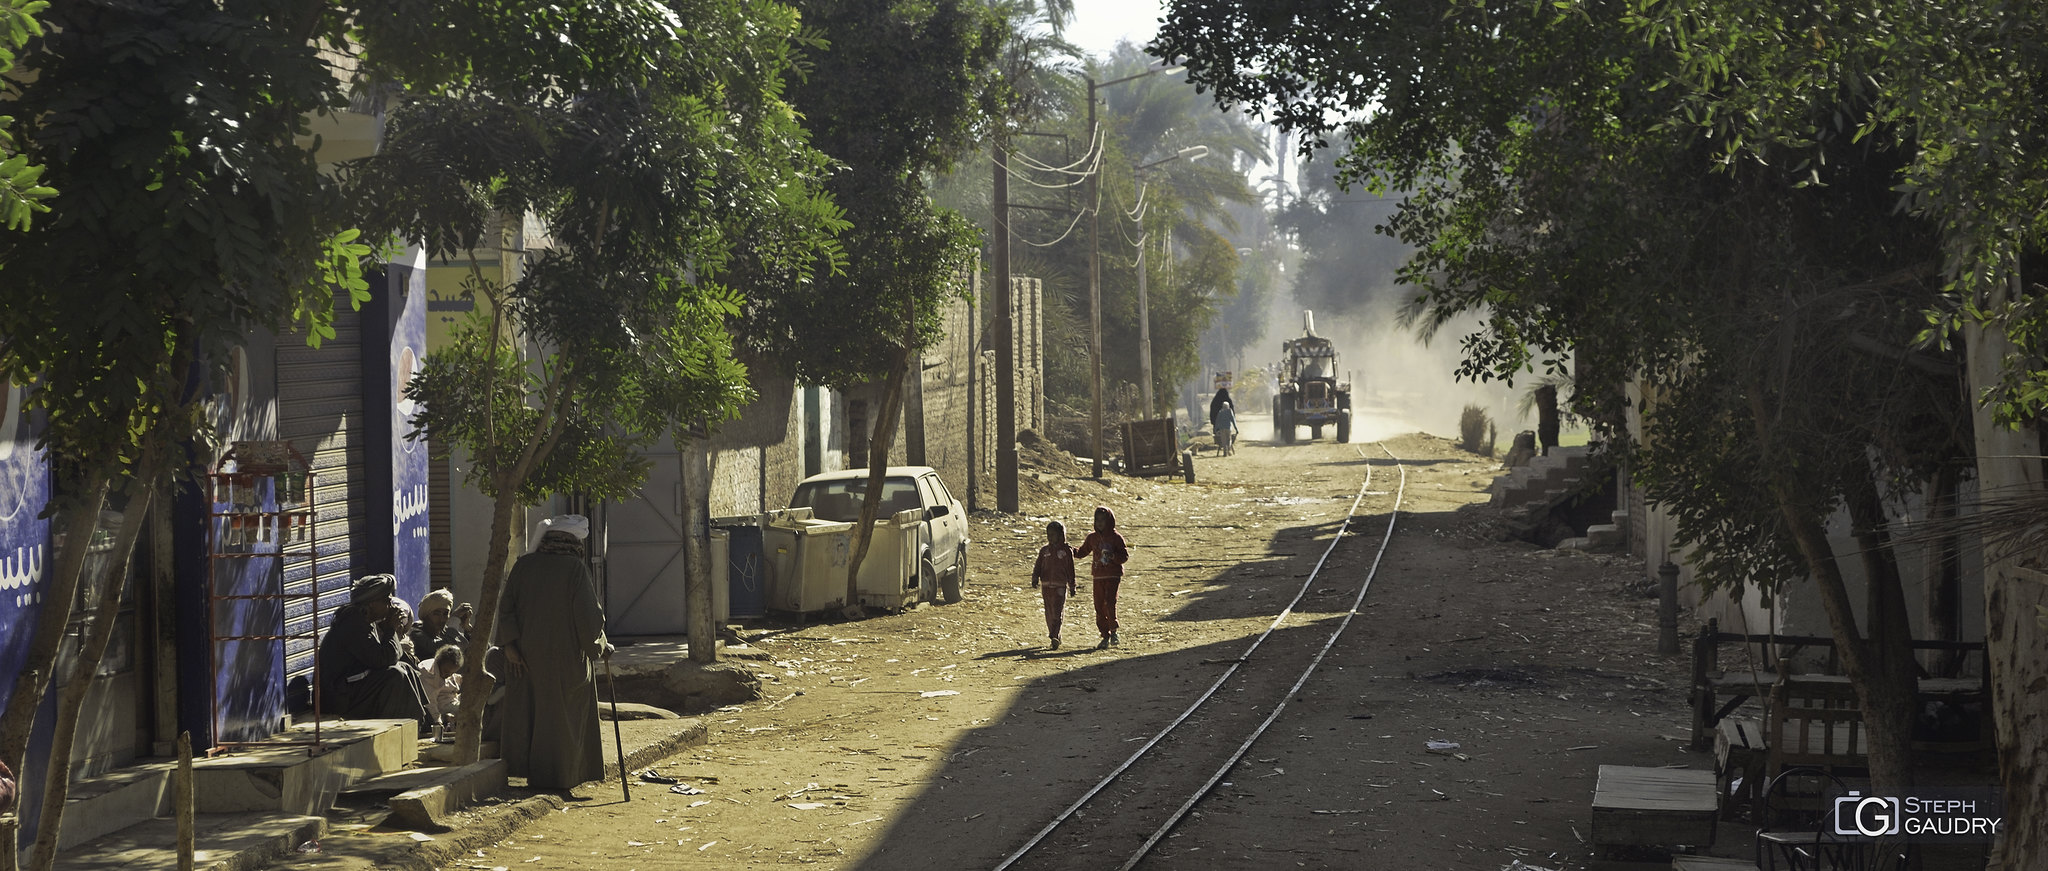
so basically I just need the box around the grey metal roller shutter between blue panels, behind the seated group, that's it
[276,291,367,697]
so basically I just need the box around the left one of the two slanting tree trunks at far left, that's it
[0,471,109,871]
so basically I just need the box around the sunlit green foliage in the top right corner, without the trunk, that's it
[1626,0,2048,422]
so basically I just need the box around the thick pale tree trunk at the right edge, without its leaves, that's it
[1964,271,2048,869]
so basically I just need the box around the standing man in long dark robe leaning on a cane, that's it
[498,514,612,789]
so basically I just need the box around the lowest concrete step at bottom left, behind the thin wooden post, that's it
[55,812,328,871]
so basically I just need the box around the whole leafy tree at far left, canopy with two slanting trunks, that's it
[0,0,369,867]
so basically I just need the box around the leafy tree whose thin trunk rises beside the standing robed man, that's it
[348,0,846,760]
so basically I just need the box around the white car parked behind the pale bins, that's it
[788,465,967,603]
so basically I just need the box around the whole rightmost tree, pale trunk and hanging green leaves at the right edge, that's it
[1634,0,2048,852]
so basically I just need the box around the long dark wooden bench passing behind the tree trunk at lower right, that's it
[1688,619,1989,752]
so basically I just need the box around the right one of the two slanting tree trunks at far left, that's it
[29,481,158,871]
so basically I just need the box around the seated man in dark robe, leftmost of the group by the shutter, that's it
[319,574,428,721]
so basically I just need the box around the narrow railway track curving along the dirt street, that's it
[995,445,1407,871]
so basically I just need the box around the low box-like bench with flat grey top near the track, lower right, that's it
[1591,764,1720,848]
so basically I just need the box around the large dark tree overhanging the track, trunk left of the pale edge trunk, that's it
[1155,2,1954,789]
